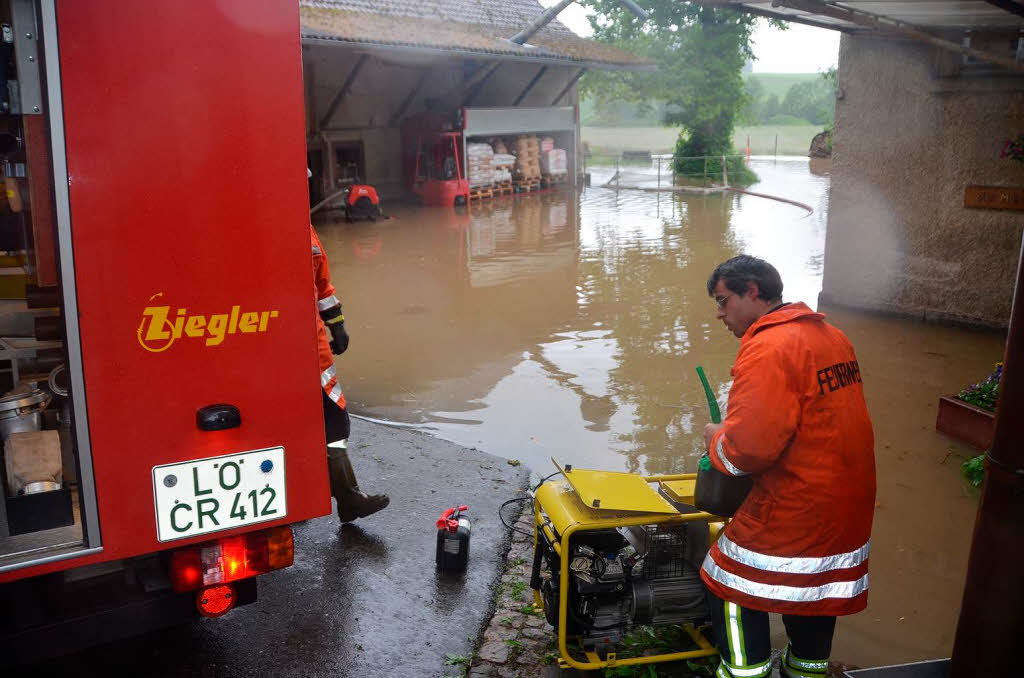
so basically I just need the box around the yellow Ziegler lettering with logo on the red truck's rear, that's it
[136,294,279,353]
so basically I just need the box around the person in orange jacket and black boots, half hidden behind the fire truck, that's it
[309,225,389,522]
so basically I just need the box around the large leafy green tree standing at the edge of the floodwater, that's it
[584,0,755,179]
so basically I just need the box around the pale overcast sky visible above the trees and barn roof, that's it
[539,0,839,73]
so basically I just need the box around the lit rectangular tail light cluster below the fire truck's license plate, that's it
[170,526,295,594]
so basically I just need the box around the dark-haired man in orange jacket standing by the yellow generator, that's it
[700,256,874,678]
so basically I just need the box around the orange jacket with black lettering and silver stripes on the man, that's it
[700,303,874,616]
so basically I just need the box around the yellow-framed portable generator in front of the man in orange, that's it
[530,460,724,671]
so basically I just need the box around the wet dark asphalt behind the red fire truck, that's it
[36,420,527,678]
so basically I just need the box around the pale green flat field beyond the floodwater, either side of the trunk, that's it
[583,125,821,156]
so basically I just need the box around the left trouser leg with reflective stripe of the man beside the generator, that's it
[708,595,771,678]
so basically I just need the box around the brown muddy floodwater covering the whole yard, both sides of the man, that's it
[316,158,1004,666]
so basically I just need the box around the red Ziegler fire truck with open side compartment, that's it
[0,0,331,666]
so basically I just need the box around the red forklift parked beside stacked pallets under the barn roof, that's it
[401,113,469,207]
